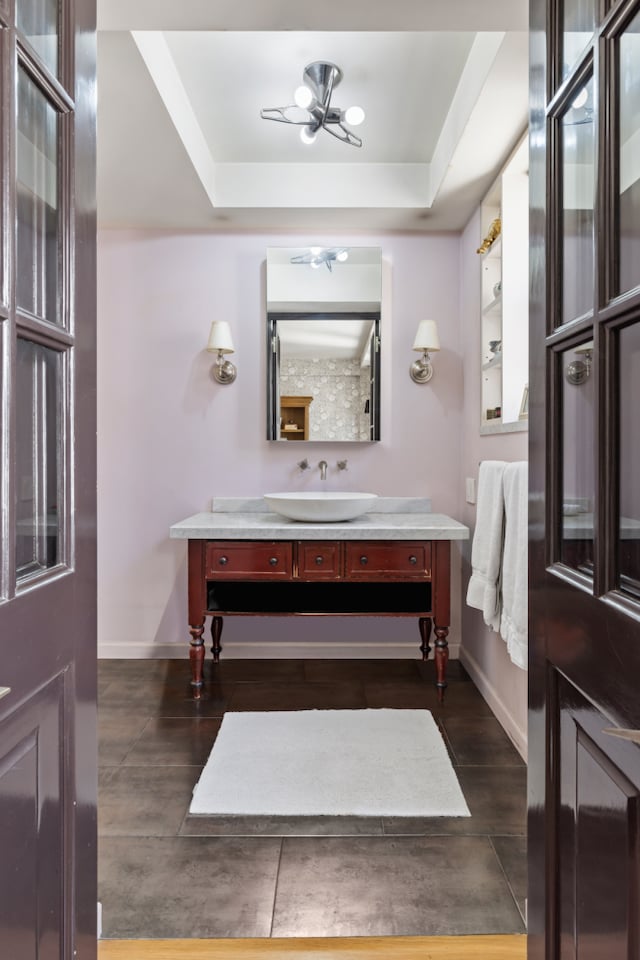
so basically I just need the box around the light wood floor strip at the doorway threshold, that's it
[98,936,527,960]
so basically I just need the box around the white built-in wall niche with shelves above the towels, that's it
[478,136,529,434]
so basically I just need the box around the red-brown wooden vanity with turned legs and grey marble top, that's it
[171,498,469,699]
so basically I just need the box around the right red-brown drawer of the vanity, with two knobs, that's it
[345,540,431,580]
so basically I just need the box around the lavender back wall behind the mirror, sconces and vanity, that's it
[98,231,464,657]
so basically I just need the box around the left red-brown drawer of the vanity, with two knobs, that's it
[205,540,293,580]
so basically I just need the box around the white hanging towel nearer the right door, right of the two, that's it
[500,461,529,670]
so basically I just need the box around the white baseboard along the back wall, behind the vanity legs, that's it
[98,640,460,660]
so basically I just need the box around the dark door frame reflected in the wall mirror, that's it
[267,307,381,443]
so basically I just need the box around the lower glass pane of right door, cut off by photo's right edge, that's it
[618,323,640,600]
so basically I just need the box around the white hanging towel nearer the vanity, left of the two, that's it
[467,460,506,630]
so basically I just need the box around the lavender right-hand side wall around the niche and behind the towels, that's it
[459,214,528,754]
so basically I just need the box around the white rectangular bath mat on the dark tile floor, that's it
[189,710,470,817]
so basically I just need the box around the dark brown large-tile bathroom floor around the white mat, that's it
[99,660,526,938]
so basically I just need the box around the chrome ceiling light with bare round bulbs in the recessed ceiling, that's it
[260,60,364,147]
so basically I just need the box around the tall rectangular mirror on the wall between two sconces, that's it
[267,246,382,443]
